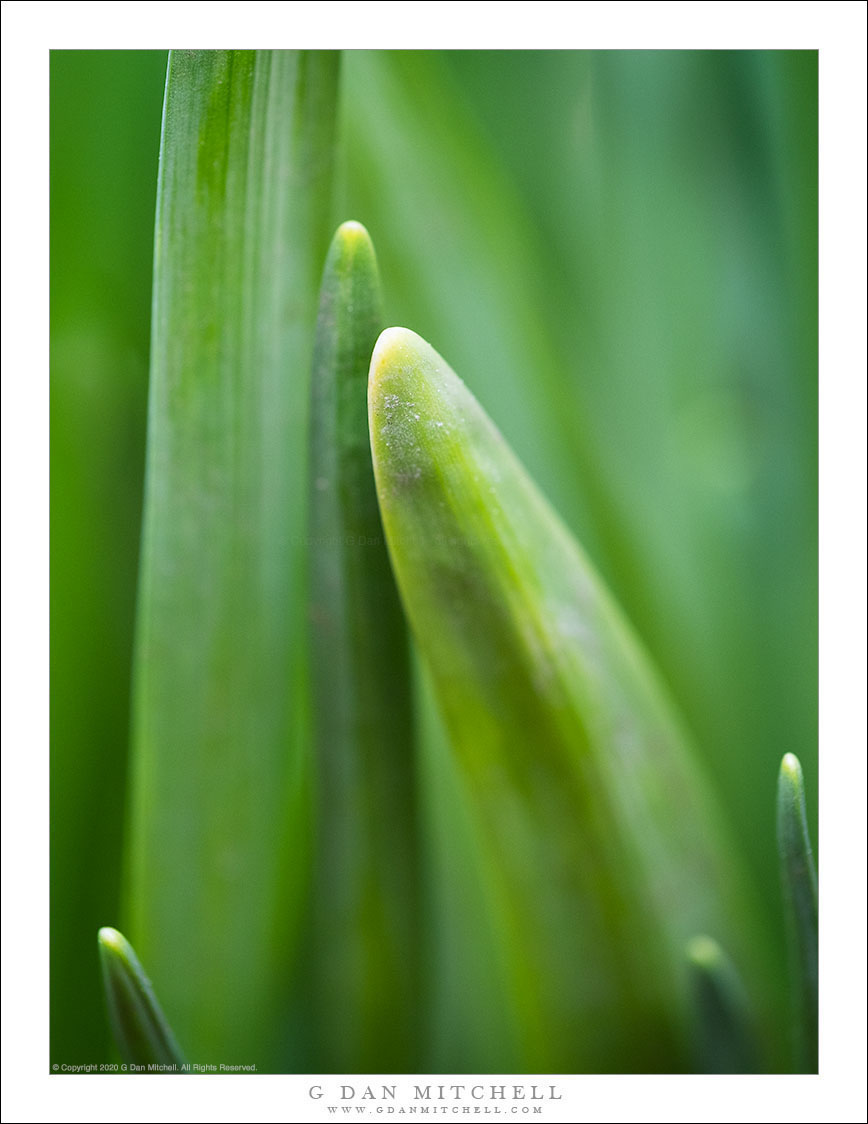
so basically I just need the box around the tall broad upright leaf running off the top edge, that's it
[128,51,337,1069]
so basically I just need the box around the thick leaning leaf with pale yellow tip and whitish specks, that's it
[369,328,778,1072]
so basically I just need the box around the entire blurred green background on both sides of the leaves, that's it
[51,51,817,1061]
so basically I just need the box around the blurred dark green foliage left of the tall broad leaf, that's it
[51,51,165,1061]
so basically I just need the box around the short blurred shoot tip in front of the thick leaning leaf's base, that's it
[687,936,758,1073]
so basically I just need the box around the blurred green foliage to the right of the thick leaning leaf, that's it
[344,52,817,1063]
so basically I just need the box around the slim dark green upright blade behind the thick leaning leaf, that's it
[310,223,419,1072]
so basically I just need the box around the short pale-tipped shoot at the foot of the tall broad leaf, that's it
[97,928,184,1067]
